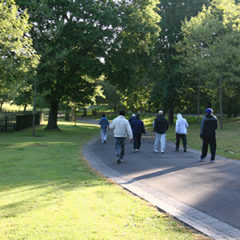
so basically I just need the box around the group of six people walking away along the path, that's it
[99,108,217,164]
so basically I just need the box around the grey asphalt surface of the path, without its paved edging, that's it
[88,129,240,229]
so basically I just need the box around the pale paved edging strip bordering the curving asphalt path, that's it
[82,137,240,240]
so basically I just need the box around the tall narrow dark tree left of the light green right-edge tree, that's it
[151,0,209,123]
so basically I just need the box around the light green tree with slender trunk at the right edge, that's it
[180,0,240,127]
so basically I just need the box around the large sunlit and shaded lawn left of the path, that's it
[0,123,207,240]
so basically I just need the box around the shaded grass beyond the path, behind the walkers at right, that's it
[143,117,240,160]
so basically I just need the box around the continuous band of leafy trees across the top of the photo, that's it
[0,0,240,129]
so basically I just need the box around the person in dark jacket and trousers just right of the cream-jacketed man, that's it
[131,113,146,152]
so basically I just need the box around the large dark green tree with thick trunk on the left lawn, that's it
[17,0,124,129]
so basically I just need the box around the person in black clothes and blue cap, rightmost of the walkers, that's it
[200,108,218,163]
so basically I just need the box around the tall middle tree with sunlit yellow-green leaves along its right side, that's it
[105,0,161,109]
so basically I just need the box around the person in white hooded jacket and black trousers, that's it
[175,113,188,152]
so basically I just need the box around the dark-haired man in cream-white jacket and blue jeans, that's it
[109,110,133,164]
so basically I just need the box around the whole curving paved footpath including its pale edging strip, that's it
[83,124,240,240]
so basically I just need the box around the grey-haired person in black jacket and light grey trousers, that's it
[153,110,168,153]
